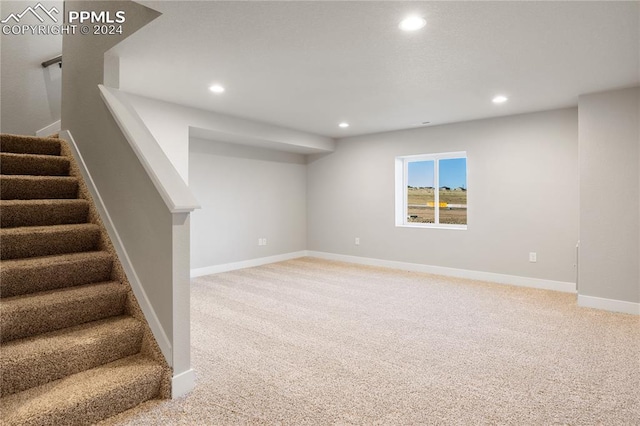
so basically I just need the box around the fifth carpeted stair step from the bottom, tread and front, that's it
[0,223,100,260]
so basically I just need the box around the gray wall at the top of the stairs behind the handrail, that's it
[0,0,63,135]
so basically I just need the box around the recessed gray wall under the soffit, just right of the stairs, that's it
[189,138,307,269]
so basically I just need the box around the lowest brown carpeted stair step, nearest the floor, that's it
[0,355,162,426]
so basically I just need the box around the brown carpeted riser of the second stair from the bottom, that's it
[0,323,142,396]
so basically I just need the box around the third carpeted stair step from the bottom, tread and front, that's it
[0,282,127,342]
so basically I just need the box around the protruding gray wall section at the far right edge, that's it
[578,88,640,303]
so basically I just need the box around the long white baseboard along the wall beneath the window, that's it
[307,251,576,293]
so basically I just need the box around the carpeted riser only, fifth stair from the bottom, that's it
[0,229,100,260]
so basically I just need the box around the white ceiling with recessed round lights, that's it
[115,1,640,137]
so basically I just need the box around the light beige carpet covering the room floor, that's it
[103,258,640,425]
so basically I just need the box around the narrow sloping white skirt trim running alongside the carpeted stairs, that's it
[60,130,173,366]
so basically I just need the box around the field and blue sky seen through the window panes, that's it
[406,158,467,225]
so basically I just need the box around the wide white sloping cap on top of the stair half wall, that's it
[98,84,200,213]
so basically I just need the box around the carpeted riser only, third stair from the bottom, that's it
[0,286,126,342]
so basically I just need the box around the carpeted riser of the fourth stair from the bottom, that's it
[0,253,113,297]
